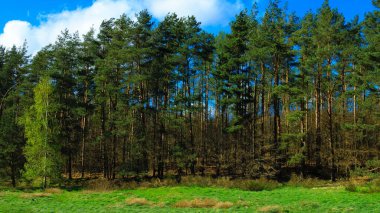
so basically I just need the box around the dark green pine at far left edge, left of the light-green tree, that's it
[0,45,29,187]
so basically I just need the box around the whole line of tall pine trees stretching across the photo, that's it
[0,0,380,185]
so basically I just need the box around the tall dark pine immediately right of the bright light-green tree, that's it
[50,30,81,179]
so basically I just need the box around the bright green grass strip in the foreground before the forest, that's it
[0,186,380,213]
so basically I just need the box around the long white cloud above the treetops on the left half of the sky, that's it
[0,0,243,54]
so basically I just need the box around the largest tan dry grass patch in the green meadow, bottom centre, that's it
[174,198,234,209]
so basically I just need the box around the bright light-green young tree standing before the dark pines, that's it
[20,77,61,188]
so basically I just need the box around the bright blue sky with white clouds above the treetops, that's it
[0,0,375,53]
